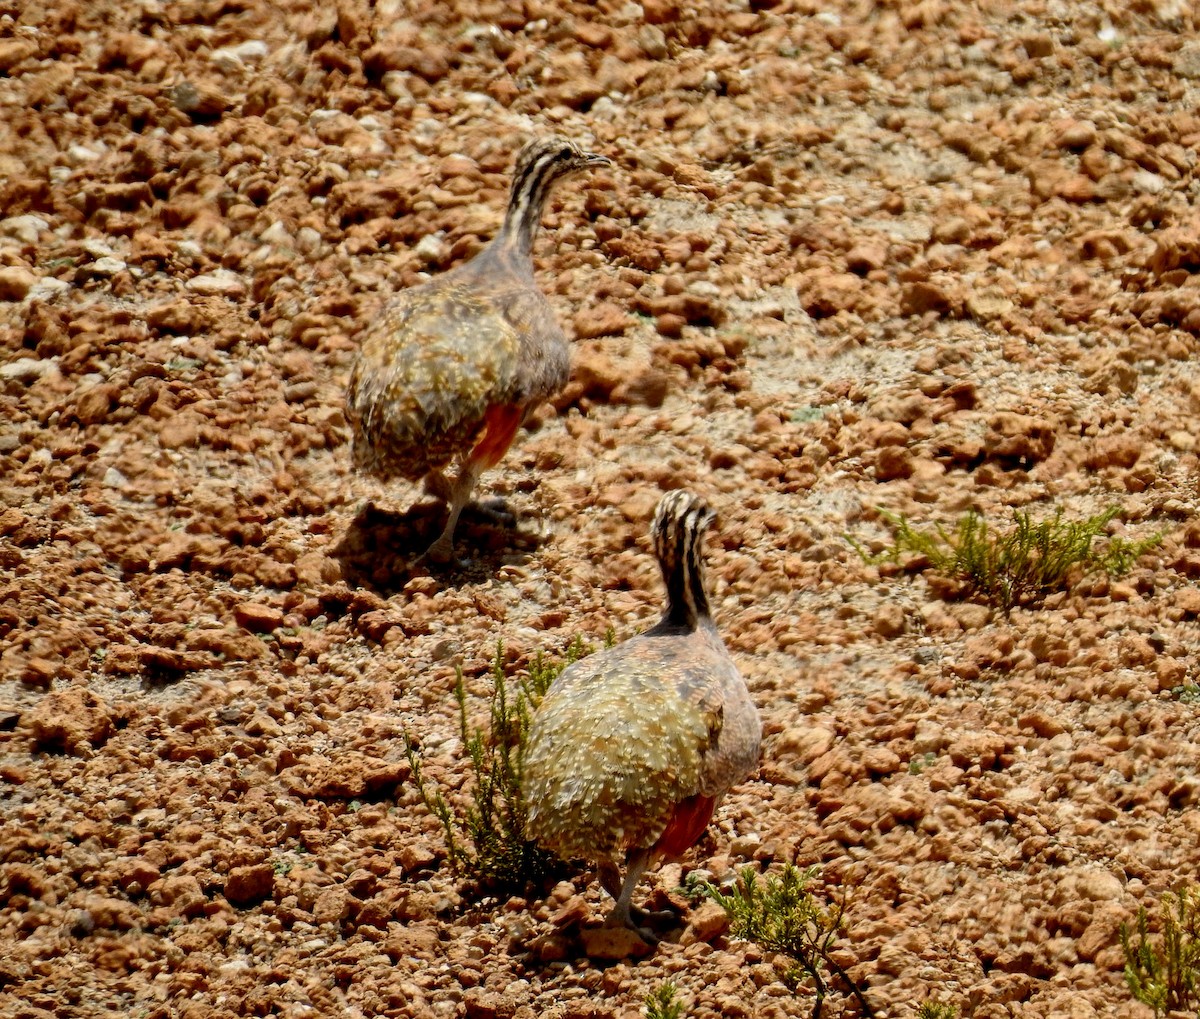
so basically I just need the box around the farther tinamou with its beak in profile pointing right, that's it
[346,138,610,562]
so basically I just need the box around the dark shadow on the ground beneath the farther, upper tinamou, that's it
[332,502,545,597]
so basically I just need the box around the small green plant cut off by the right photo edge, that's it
[1121,886,1200,1019]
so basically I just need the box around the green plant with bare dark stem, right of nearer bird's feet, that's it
[704,863,875,1019]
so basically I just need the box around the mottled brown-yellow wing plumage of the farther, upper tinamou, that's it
[347,277,521,480]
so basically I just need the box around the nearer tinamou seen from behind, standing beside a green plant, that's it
[522,491,762,943]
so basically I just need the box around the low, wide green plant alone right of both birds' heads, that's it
[851,506,1164,613]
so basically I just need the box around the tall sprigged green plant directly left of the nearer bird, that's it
[404,631,612,893]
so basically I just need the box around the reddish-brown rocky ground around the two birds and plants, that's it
[0,0,1200,1019]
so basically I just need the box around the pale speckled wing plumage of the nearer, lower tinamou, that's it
[524,637,714,859]
